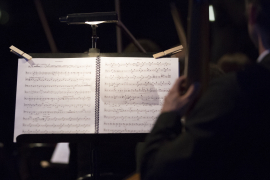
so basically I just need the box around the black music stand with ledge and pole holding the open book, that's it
[16,53,153,179]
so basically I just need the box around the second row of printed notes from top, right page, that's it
[105,68,171,74]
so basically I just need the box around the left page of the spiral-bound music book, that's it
[14,58,96,141]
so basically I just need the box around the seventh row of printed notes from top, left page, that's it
[24,103,91,108]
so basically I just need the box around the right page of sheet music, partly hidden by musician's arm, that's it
[99,57,179,133]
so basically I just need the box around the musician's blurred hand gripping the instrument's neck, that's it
[161,76,200,116]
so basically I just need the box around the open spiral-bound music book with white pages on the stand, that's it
[14,57,179,140]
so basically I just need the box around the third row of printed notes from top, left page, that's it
[25,77,91,82]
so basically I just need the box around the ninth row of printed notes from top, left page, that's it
[23,116,91,122]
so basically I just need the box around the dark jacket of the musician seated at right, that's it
[140,54,270,180]
